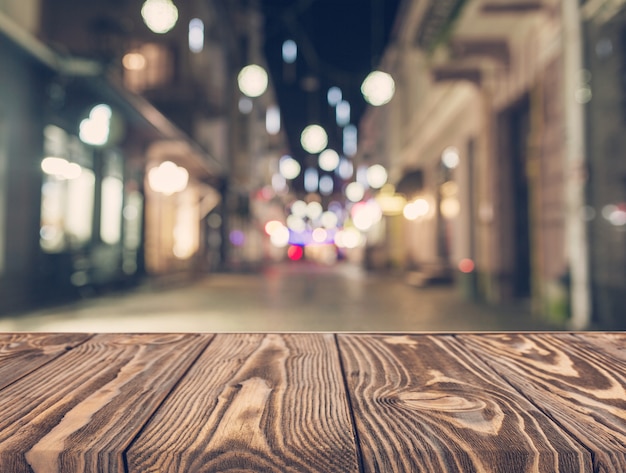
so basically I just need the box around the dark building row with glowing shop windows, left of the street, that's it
[0,0,282,312]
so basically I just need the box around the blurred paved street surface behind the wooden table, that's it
[0,262,560,332]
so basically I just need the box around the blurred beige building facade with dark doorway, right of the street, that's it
[361,0,593,328]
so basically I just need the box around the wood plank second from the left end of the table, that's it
[0,334,211,473]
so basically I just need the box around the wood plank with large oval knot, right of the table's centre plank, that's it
[338,335,591,473]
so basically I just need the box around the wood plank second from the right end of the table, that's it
[458,334,626,472]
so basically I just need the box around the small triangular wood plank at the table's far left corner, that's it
[0,333,91,389]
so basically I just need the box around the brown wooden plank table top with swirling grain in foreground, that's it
[0,332,626,473]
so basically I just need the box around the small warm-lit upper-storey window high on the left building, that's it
[122,43,173,93]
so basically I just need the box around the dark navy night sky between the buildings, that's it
[261,0,400,160]
